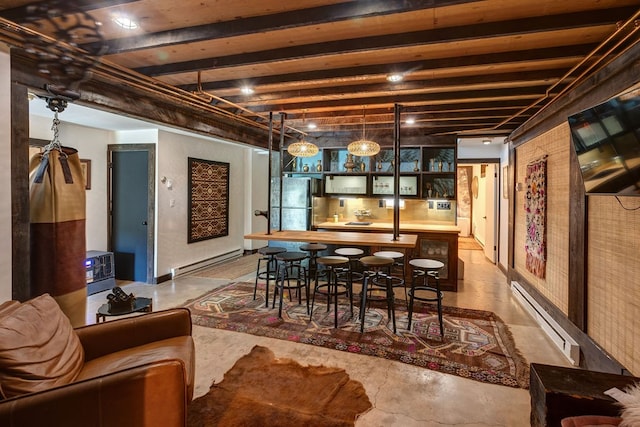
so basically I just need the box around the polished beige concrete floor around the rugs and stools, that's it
[87,250,569,427]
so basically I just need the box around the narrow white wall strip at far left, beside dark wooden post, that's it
[0,43,11,302]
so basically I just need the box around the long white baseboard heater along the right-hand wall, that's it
[511,281,580,366]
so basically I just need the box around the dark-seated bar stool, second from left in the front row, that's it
[271,252,309,317]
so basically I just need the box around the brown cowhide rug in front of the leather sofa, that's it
[187,346,371,427]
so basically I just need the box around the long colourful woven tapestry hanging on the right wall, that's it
[524,158,547,279]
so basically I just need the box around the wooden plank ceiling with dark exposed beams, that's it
[0,0,640,145]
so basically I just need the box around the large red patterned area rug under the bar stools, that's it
[185,282,529,388]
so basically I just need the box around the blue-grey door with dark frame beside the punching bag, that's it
[107,144,155,283]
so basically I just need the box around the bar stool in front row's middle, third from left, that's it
[309,256,353,328]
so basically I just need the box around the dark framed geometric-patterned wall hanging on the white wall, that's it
[188,157,229,243]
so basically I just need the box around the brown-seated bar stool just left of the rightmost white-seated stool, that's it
[360,255,396,334]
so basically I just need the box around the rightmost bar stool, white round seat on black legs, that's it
[407,258,444,338]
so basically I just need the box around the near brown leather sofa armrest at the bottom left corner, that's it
[0,360,188,427]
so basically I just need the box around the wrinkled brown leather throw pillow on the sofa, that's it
[0,294,84,398]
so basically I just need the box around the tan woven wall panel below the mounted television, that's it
[587,196,640,375]
